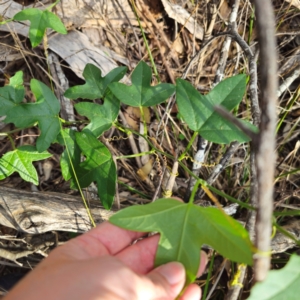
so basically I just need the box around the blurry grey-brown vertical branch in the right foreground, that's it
[254,0,277,281]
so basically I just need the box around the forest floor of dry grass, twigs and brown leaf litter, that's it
[0,0,300,299]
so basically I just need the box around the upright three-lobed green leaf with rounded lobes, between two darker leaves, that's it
[109,61,175,107]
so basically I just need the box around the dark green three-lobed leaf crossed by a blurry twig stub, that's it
[176,75,256,144]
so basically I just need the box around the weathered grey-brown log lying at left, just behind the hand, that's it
[0,187,113,234]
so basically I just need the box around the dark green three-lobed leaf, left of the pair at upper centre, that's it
[65,64,127,100]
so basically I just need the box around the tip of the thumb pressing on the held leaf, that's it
[146,262,185,300]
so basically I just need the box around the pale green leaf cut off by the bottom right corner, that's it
[248,255,300,300]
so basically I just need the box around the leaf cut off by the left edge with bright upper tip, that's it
[0,71,25,116]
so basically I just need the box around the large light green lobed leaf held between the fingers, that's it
[109,199,252,285]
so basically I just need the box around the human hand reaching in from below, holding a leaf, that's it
[5,222,207,300]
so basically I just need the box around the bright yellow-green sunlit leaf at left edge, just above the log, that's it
[0,145,51,185]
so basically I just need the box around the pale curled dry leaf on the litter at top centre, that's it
[161,0,203,40]
